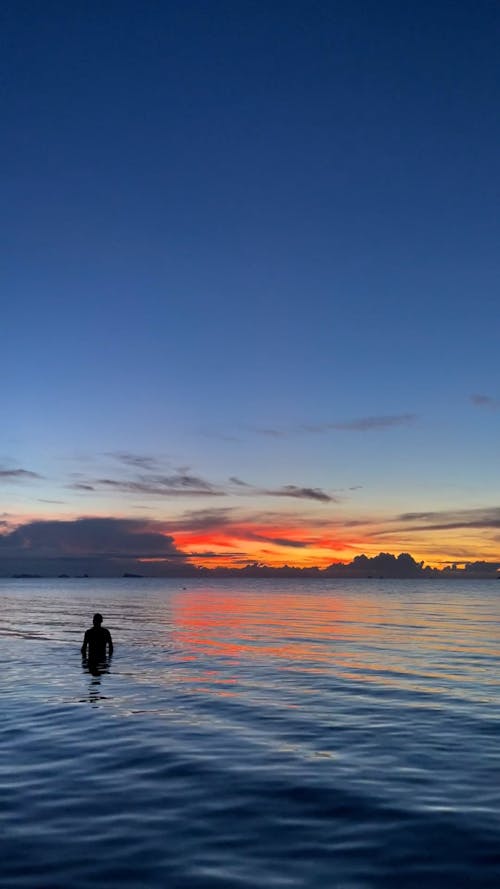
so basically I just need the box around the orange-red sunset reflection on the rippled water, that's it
[170,585,494,691]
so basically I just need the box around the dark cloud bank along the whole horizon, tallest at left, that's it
[0,518,500,578]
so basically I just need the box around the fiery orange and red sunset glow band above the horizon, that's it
[0,506,500,570]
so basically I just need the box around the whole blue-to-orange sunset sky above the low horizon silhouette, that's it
[0,0,500,570]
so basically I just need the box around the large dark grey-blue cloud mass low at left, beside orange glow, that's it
[0,517,186,575]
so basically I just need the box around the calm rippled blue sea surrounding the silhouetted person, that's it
[0,579,500,889]
